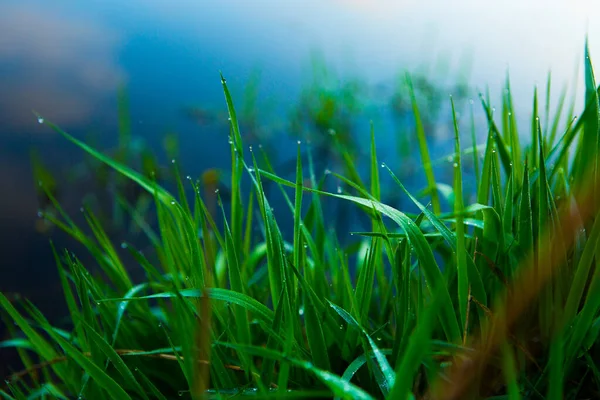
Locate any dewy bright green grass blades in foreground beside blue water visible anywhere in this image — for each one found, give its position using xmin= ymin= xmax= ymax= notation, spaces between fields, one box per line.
xmin=0 ymin=41 xmax=600 ymax=400
